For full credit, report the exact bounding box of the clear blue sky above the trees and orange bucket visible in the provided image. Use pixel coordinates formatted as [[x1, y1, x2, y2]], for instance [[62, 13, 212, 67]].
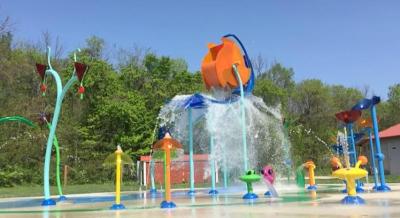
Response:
[[0, 0, 400, 98]]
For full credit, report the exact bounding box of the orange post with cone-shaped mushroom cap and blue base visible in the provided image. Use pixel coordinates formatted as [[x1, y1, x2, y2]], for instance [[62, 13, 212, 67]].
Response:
[[153, 133, 182, 208]]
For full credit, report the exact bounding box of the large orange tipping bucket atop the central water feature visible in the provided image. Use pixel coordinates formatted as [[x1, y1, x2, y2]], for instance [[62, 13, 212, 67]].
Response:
[[201, 37, 251, 89]]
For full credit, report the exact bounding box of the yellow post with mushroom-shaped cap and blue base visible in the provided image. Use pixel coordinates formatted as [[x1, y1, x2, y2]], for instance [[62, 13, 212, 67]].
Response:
[[104, 145, 133, 210]]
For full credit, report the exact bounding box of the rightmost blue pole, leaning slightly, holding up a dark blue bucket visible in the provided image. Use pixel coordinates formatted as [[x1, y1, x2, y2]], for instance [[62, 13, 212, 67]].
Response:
[[371, 104, 391, 192]]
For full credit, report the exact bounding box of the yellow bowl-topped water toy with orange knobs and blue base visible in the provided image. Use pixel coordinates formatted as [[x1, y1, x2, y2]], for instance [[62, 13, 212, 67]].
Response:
[[331, 156, 368, 204]]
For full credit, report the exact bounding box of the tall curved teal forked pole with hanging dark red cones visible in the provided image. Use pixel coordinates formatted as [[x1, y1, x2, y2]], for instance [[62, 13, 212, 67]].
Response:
[[36, 47, 89, 206]]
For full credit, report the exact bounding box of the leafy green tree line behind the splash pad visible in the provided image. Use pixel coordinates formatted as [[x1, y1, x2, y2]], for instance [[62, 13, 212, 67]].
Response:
[[0, 22, 400, 186]]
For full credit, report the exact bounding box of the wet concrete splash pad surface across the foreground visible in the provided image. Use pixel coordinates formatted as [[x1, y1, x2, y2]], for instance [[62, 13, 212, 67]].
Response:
[[0, 184, 400, 218]]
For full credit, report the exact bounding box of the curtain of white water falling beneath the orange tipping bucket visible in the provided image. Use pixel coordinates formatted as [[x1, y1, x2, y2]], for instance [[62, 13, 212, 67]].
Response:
[[159, 92, 290, 183]]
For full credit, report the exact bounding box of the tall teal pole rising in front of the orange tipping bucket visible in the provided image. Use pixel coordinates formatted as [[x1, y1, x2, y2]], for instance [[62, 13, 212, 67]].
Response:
[[232, 64, 248, 172]]
